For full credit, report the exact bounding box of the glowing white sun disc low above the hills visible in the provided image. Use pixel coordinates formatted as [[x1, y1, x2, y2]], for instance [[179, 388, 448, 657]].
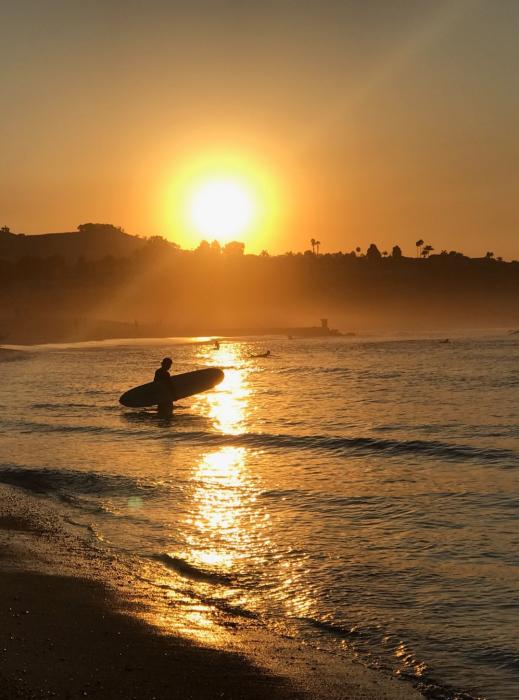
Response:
[[187, 177, 257, 242]]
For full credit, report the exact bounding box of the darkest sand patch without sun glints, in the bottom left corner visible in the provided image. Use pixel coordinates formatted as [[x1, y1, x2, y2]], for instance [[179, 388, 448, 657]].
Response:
[[0, 572, 304, 700]]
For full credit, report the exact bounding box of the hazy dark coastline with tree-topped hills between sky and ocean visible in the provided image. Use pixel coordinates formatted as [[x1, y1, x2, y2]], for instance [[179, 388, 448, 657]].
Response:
[[0, 224, 519, 343]]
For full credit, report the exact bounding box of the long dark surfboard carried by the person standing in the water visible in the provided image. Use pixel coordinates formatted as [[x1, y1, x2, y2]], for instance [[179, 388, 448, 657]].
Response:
[[119, 367, 224, 408]]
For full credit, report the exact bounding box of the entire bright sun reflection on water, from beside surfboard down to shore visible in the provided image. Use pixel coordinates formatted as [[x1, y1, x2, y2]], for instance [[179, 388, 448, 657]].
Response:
[[146, 343, 315, 644]]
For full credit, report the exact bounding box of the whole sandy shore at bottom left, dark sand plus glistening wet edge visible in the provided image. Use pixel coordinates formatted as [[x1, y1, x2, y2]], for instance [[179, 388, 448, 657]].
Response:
[[0, 484, 423, 700]]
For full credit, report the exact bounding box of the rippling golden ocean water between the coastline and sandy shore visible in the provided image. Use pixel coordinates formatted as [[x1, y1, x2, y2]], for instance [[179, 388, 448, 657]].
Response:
[[0, 332, 519, 700]]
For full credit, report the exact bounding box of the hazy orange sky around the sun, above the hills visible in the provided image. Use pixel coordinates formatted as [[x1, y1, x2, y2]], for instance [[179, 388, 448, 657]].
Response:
[[0, 0, 519, 259]]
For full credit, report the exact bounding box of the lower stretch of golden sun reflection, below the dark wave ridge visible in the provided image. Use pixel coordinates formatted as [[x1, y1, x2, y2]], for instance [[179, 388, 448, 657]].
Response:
[[152, 447, 256, 645]]
